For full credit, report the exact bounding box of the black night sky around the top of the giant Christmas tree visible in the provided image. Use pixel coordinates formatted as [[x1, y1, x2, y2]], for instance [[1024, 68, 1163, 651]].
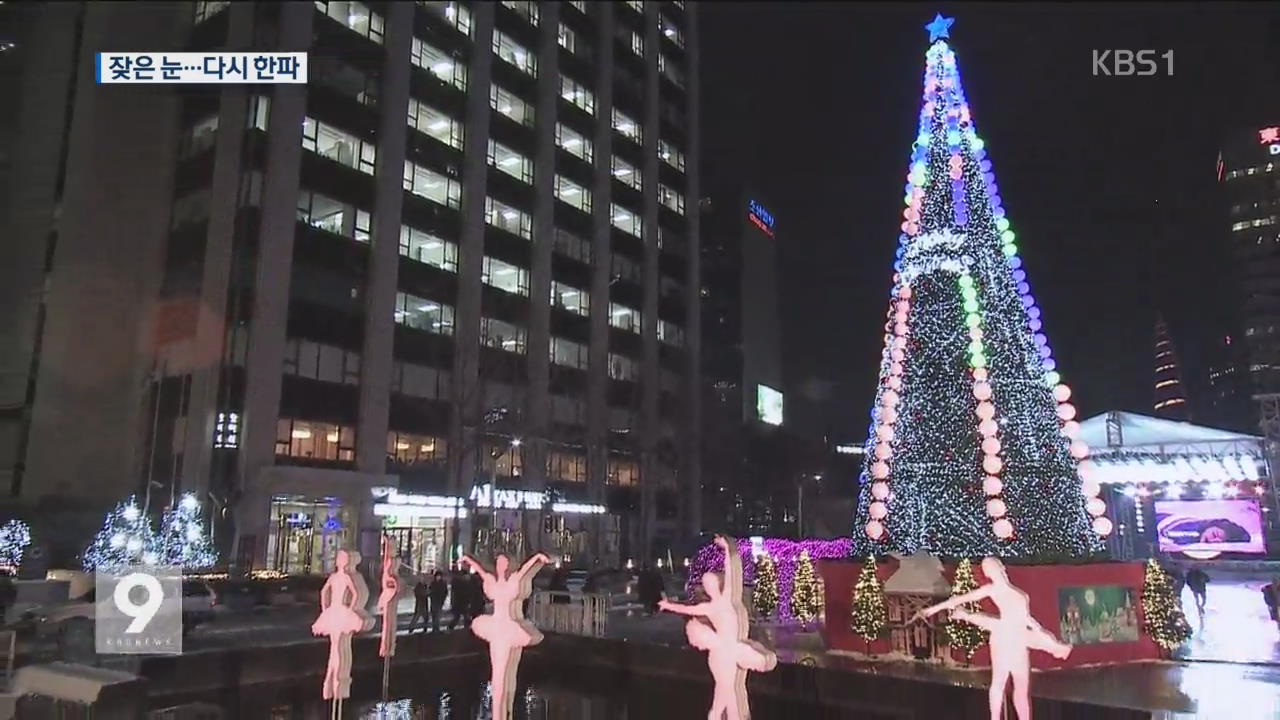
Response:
[[700, 3, 1280, 439]]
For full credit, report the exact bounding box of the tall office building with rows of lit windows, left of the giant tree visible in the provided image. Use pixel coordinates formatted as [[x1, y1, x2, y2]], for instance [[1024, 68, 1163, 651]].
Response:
[[2, 1, 700, 573]]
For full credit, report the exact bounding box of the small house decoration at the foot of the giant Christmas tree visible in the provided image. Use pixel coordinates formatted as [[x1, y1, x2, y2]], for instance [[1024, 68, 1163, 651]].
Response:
[[884, 552, 951, 662]]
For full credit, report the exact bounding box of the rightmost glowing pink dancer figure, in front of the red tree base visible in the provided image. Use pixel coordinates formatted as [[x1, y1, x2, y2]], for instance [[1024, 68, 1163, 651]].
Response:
[[913, 557, 1071, 720]]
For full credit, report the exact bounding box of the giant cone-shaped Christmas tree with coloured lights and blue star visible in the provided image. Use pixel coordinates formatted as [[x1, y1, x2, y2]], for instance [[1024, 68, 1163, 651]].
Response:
[[854, 17, 1111, 559]]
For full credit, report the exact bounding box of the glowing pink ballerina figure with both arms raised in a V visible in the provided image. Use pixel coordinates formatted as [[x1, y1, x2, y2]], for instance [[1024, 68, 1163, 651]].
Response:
[[461, 552, 552, 720]]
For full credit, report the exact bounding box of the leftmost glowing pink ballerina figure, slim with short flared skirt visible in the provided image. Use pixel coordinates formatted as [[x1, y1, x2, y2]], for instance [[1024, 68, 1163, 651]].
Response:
[[311, 550, 374, 717]]
